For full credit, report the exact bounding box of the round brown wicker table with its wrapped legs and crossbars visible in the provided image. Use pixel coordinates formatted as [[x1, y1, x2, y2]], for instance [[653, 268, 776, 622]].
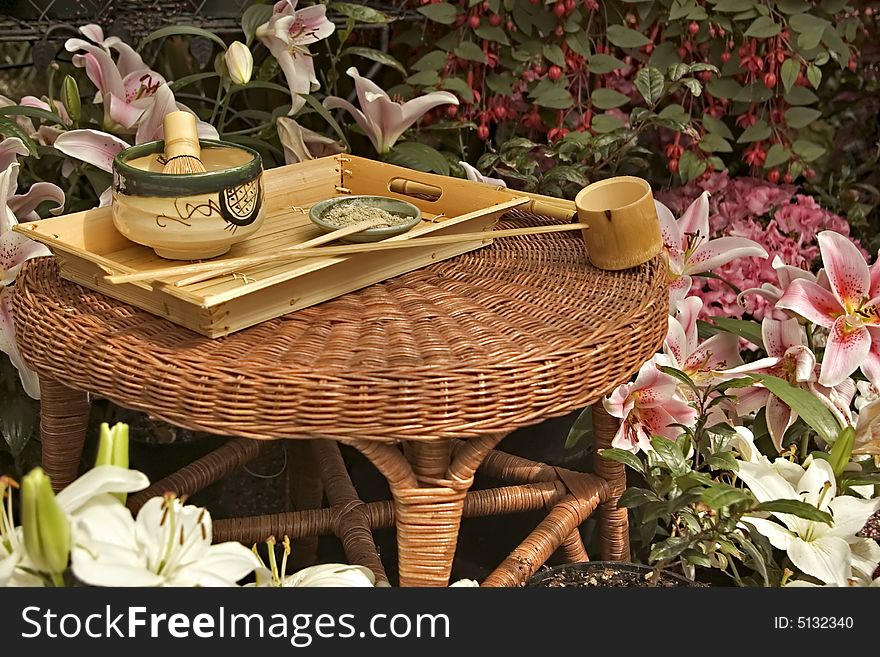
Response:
[[12, 216, 667, 586]]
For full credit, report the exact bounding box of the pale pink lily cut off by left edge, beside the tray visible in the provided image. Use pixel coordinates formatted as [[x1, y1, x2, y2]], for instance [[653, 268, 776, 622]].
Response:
[[0, 162, 51, 399]]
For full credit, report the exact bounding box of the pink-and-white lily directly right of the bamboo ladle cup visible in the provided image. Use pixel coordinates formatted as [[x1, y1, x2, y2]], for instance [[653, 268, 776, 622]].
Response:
[[655, 192, 767, 303]]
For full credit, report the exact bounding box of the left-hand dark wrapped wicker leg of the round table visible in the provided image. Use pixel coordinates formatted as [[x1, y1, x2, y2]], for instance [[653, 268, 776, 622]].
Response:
[[40, 374, 90, 492]]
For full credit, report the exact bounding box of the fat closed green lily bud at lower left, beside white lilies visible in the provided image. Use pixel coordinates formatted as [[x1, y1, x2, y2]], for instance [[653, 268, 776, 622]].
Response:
[[21, 468, 70, 584]]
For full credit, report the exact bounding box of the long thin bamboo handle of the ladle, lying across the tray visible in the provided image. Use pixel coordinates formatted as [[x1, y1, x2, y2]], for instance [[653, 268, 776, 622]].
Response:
[[104, 223, 589, 284]]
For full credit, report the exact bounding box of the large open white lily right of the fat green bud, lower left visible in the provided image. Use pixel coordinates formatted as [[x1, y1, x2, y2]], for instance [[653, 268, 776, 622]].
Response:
[[72, 492, 261, 586]]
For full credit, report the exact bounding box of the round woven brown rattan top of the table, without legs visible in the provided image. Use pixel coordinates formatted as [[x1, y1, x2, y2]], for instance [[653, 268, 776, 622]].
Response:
[[12, 217, 667, 440]]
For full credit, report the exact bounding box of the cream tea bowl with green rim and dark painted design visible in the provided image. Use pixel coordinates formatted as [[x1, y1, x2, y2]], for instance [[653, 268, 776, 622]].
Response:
[[112, 140, 264, 260]]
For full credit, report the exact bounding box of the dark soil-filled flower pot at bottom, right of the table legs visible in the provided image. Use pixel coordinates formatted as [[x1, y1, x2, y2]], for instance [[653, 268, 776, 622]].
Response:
[[526, 561, 700, 588]]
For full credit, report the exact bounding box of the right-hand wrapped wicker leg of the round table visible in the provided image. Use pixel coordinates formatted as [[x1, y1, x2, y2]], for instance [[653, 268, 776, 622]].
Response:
[[593, 402, 630, 561]]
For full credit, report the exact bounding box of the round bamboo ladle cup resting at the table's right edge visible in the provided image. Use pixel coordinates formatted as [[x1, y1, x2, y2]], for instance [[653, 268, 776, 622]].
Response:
[[574, 176, 663, 270]]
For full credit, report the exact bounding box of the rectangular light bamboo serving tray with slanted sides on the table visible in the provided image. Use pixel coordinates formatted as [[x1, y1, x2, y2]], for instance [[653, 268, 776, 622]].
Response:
[[15, 155, 540, 338]]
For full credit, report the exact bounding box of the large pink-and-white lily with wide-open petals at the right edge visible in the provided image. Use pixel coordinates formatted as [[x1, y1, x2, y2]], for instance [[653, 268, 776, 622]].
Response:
[[776, 230, 880, 386]]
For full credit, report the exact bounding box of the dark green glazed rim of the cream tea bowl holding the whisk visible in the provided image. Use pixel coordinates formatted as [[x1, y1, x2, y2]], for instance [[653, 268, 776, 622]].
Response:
[[113, 139, 263, 197]]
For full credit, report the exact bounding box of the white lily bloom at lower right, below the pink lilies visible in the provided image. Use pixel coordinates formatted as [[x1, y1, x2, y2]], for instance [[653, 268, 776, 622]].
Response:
[[738, 459, 880, 586]]
